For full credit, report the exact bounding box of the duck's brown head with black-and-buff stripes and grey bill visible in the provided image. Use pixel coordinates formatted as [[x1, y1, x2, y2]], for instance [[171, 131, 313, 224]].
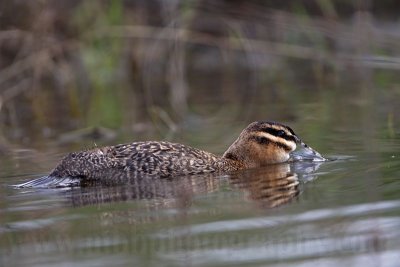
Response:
[[223, 121, 324, 168]]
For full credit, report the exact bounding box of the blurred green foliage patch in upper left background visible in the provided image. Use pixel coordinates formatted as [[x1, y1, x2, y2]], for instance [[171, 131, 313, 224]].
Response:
[[75, 0, 123, 128]]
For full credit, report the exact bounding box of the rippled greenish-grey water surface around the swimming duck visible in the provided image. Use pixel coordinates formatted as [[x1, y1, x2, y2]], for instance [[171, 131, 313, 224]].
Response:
[[0, 116, 400, 266]]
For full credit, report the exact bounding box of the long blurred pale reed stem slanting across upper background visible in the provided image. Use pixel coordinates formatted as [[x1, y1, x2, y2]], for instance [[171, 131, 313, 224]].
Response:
[[97, 26, 400, 69]]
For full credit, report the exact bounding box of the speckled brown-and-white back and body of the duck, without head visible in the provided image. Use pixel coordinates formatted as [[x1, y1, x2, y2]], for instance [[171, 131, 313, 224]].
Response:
[[50, 141, 220, 180]]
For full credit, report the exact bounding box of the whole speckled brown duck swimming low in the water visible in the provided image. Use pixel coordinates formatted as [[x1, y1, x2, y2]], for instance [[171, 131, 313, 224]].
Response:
[[21, 122, 324, 186]]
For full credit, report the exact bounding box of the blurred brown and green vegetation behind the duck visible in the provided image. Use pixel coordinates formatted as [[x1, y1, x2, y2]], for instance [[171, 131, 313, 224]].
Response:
[[0, 0, 400, 154]]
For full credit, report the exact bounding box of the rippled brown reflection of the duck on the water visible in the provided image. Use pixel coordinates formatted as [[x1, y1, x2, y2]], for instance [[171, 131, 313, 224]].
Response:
[[70, 163, 310, 209]]
